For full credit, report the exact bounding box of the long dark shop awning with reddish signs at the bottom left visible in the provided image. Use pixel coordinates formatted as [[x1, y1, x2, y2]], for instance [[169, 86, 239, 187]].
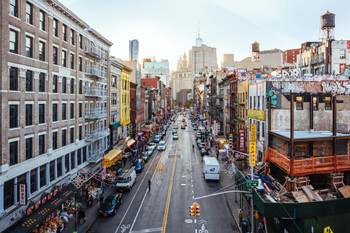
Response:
[[5, 184, 76, 233]]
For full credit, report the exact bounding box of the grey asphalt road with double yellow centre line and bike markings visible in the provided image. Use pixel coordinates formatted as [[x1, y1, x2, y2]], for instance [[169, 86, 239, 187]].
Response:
[[92, 116, 238, 233]]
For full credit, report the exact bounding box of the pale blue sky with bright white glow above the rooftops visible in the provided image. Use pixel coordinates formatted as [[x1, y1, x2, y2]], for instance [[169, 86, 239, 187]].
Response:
[[60, 0, 350, 70]]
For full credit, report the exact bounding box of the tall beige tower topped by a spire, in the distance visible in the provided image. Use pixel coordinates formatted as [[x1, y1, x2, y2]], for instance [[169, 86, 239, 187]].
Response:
[[190, 36, 218, 75]]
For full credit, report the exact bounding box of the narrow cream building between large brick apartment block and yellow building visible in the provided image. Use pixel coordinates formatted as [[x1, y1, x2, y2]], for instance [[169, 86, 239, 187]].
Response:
[[108, 57, 124, 148]]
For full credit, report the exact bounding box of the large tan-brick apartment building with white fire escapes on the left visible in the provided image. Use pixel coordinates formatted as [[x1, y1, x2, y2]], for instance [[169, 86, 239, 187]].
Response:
[[0, 0, 112, 231]]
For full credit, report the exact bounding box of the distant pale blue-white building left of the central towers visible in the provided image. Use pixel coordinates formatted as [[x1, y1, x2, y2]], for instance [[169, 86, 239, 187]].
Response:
[[142, 59, 170, 87]]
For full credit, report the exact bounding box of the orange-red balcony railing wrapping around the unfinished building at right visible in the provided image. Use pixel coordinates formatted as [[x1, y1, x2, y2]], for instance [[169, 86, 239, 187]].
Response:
[[267, 148, 350, 176]]
